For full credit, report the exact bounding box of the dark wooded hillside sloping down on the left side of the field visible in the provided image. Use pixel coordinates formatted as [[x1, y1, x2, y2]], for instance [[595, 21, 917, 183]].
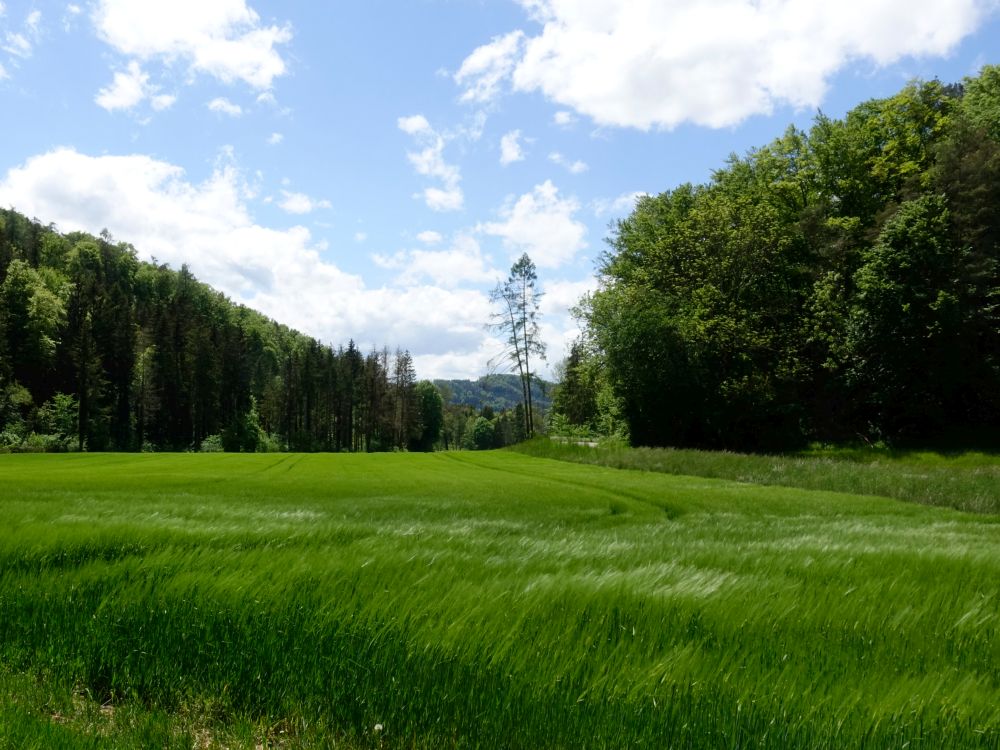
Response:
[[0, 210, 443, 451]]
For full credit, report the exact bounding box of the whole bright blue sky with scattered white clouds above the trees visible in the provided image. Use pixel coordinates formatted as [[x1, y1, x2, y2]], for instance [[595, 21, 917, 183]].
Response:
[[0, 0, 1000, 377]]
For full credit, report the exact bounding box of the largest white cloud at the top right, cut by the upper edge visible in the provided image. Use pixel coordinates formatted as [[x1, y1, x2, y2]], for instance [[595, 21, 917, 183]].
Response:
[[454, 0, 996, 129]]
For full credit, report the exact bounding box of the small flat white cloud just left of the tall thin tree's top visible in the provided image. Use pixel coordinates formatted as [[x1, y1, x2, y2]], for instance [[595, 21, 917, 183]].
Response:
[[372, 234, 500, 290]]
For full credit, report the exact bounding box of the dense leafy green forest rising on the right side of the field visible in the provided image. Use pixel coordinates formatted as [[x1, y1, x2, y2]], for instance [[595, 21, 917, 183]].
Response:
[[554, 66, 1000, 450]]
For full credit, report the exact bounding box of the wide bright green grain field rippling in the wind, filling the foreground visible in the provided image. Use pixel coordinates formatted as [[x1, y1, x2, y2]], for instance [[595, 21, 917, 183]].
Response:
[[0, 452, 1000, 748]]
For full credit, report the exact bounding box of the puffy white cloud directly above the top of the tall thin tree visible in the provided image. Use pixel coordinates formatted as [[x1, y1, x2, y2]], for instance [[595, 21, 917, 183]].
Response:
[[477, 180, 587, 268]]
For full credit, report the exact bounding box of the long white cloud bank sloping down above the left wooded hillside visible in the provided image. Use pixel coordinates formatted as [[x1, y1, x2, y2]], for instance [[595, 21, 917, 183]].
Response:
[[0, 148, 500, 378]]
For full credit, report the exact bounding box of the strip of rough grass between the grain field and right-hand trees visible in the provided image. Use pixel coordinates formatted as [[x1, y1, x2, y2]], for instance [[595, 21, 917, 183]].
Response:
[[513, 438, 1000, 514]]
